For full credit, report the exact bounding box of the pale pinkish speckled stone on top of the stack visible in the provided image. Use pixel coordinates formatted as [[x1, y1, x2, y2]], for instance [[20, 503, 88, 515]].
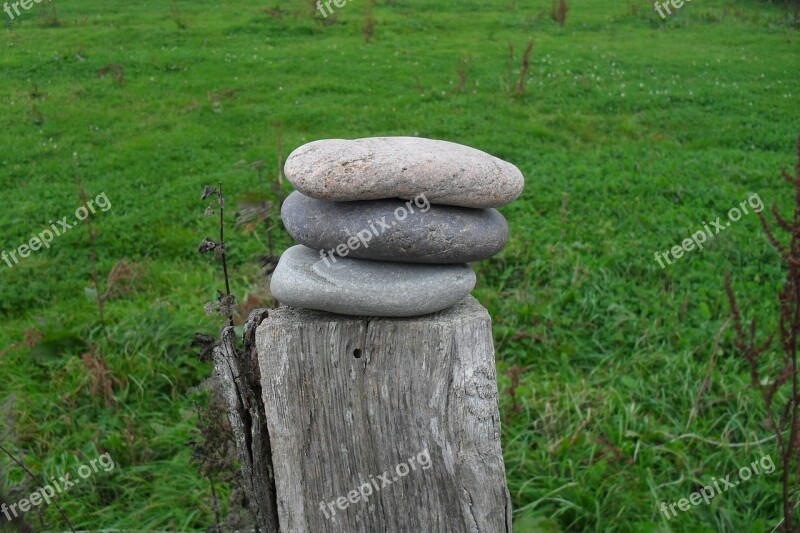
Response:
[[284, 137, 525, 207]]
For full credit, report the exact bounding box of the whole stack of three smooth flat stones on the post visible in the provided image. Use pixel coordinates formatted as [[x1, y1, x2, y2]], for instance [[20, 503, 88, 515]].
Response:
[[271, 137, 524, 317]]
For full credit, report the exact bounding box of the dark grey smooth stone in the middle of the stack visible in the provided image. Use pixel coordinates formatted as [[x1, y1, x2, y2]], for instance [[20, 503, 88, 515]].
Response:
[[281, 191, 508, 263]]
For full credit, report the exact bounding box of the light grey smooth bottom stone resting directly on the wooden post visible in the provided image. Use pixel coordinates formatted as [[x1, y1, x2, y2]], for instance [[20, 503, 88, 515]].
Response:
[[270, 245, 475, 317]]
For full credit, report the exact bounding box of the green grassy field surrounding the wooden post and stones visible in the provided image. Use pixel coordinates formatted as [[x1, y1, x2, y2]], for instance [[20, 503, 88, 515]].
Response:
[[0, 0, 800, 532]]
